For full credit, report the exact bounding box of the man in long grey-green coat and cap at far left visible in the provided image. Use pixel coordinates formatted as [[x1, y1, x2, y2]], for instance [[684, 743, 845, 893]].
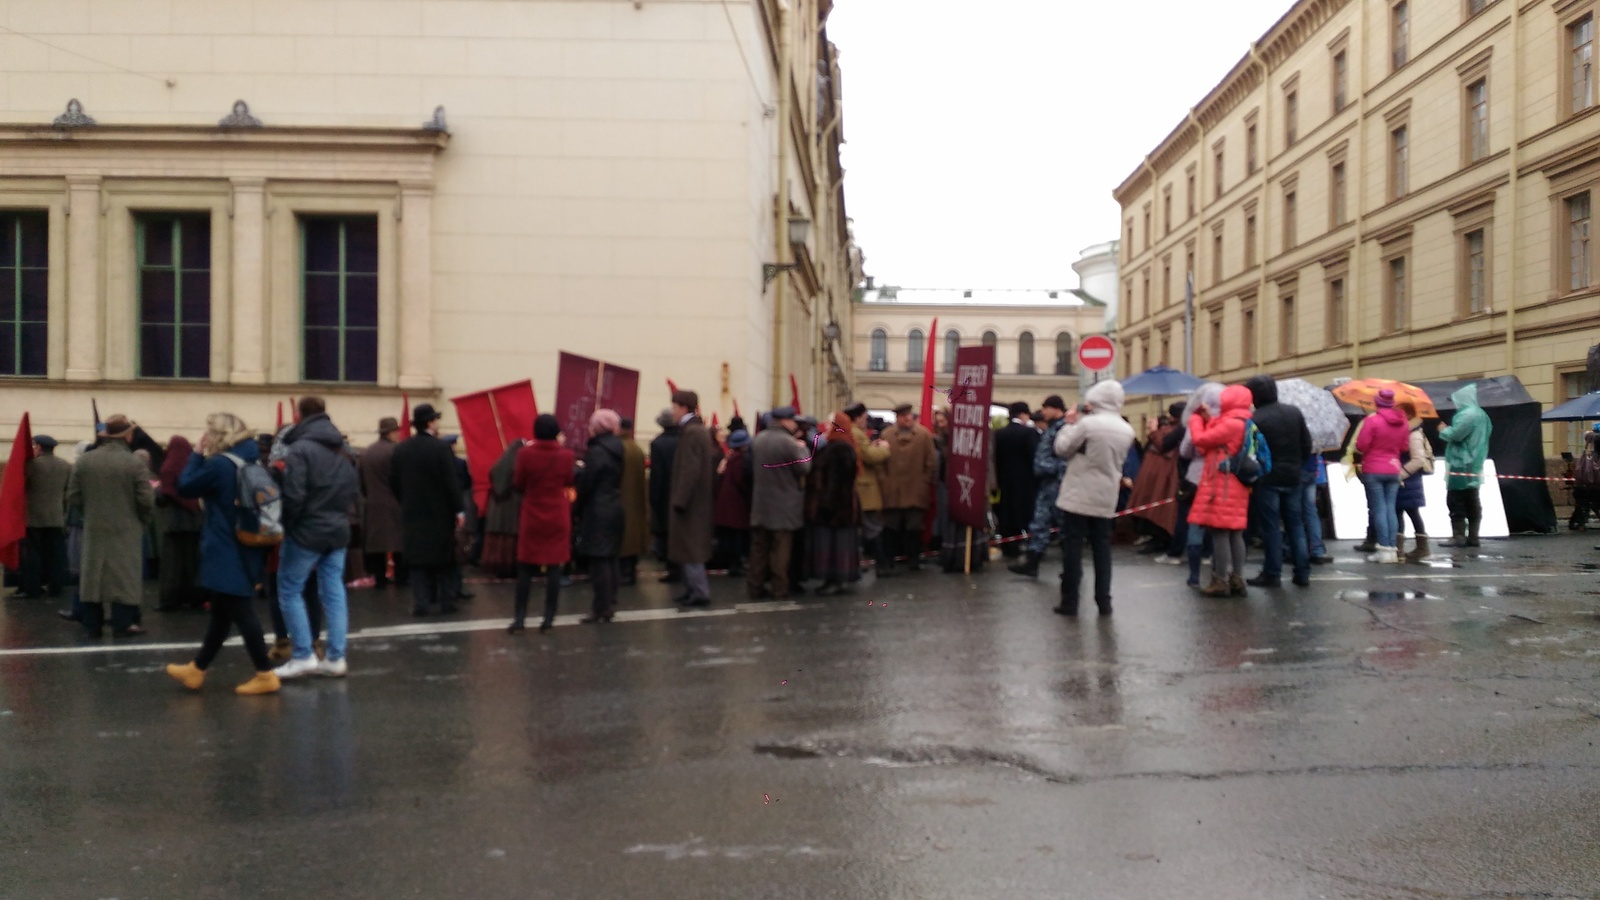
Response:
[[67, 415, 155, 639]]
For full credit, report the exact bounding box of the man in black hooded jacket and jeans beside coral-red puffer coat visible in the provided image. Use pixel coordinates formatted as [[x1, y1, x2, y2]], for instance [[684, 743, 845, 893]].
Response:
[[1245, 375, 1312, 588]]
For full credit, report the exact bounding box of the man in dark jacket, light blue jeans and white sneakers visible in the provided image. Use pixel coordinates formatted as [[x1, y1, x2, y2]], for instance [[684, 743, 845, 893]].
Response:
[[277, 397, 360, 679]]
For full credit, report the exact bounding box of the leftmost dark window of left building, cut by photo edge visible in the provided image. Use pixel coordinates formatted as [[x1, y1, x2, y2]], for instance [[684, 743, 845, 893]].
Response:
[[0, 213, 50, 376]]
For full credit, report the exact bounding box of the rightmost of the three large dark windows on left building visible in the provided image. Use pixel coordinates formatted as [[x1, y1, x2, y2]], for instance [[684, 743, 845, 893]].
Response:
[[301, 216, 378, 384]]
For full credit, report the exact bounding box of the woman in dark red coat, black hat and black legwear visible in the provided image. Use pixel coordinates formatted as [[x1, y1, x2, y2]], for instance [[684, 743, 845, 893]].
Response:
[[507, 413, 576, 634]]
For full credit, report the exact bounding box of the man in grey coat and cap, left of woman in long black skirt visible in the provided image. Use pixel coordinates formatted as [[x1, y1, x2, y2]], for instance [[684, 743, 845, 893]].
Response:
[[746, 407, 811, 601]]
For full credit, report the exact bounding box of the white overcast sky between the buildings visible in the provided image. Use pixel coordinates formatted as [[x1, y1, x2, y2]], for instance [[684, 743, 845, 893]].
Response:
[[829, 0, 1293, 287]]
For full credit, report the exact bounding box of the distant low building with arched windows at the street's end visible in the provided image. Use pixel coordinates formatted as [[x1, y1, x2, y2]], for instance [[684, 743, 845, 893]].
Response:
[[854, 283, 1115, 408]]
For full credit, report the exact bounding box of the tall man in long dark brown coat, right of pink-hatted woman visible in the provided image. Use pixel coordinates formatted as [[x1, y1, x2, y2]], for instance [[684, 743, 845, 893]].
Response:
[[667, 391, 717, 607]]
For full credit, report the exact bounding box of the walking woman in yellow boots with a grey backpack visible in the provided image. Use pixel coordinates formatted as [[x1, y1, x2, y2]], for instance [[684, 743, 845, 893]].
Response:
[[166, 413, 278, 695]]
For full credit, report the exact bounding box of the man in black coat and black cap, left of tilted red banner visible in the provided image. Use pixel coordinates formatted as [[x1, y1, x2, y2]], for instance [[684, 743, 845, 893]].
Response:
[[389, 404, 464, 617]]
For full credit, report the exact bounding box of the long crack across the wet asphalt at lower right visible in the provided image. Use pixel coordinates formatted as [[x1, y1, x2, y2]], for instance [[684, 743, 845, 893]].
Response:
[[754, 740, 1600, 785]]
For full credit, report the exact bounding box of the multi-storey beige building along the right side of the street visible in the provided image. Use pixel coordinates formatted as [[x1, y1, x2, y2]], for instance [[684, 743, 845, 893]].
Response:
[[1115, 0, 1600, 452]]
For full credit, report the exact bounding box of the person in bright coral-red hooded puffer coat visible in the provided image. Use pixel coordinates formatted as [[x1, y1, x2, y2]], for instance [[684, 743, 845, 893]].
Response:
[[1189, 384, 1254, 597]]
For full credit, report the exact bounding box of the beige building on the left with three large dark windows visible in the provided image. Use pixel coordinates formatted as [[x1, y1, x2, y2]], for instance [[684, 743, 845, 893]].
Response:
[[0, 0, 861, 440]]
